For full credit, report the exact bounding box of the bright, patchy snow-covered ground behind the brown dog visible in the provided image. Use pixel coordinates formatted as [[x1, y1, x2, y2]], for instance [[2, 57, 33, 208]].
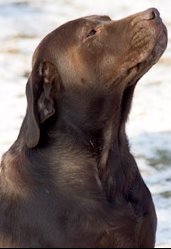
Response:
[[0, 0, 171, 248]]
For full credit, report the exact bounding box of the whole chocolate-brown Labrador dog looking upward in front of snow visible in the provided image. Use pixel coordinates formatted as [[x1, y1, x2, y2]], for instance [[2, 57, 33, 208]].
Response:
[[0, 9, 167, 248]]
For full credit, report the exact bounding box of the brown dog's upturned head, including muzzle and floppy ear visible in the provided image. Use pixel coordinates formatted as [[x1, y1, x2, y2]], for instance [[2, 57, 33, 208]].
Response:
[[26, 9, 167, 148]]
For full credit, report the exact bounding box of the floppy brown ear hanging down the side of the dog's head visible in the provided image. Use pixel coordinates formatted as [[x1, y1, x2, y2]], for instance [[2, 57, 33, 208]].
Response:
[[25, 62, 59, 148]]
